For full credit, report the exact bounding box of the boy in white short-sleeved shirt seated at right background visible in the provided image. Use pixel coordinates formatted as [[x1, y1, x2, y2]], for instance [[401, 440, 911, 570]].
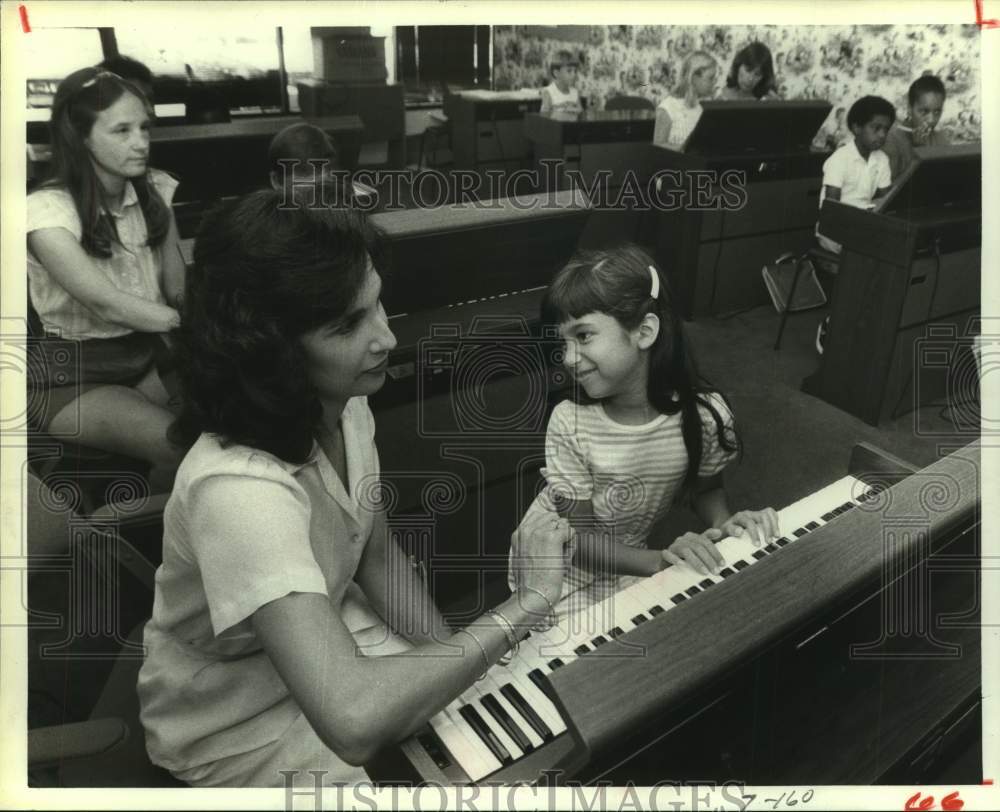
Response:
[[816, 96, 896, 254]]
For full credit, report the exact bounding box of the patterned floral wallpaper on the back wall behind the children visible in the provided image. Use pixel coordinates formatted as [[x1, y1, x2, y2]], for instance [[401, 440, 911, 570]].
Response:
[[493, 25, 982, 147]]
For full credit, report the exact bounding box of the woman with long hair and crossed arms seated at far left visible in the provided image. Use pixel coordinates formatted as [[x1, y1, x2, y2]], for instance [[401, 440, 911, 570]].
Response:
[[27, 68, 185, 488]]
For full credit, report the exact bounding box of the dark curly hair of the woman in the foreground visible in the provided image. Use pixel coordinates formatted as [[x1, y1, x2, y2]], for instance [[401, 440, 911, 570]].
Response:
[[171, 190, 382, 463]]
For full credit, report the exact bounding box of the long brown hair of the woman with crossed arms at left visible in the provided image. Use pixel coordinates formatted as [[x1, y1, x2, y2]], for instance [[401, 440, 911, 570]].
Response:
[[43, 68, 170, 257]]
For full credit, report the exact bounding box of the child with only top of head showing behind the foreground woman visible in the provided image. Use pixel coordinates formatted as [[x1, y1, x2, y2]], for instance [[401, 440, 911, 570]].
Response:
[[267, 121, 378, 211]]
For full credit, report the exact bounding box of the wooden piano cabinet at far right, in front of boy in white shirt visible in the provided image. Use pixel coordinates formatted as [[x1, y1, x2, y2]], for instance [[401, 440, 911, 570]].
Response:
[[802, 201, 982, 425]]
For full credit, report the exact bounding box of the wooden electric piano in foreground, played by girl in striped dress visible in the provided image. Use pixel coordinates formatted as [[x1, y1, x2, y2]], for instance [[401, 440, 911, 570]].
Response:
[[369, 442, 982, 786]]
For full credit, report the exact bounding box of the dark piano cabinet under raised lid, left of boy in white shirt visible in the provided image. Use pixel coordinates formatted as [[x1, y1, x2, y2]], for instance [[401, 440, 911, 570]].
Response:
[[647, 145, 829, 318]]
